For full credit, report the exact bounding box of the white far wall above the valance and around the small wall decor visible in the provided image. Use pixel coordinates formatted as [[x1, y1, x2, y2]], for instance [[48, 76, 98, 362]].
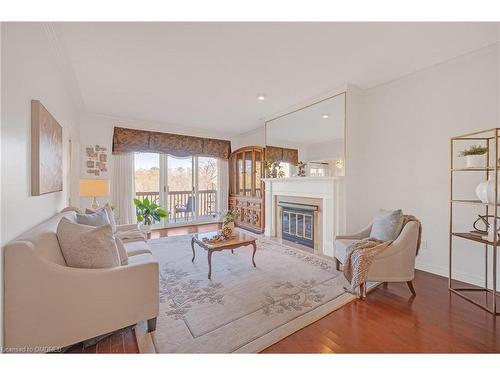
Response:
[[80, 114, 230, 208]]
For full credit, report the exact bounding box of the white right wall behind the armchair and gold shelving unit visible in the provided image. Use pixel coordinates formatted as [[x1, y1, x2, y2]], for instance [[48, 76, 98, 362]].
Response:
[[347, 44, 500, 285]]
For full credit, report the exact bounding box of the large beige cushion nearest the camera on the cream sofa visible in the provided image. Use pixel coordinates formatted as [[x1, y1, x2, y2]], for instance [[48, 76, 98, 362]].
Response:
[[57, 217, 120, 268]]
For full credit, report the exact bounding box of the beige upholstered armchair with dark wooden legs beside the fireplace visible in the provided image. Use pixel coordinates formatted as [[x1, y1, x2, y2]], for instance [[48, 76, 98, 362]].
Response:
[[334, 221, 419, 296]]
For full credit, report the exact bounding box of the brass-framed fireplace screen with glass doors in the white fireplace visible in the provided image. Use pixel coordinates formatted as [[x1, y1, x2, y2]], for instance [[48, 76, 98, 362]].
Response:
[[280, 203, 317, 249]]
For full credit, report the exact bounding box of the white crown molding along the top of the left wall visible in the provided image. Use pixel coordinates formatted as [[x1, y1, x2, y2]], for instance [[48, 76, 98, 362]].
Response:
[[41, 22, 86, 113]]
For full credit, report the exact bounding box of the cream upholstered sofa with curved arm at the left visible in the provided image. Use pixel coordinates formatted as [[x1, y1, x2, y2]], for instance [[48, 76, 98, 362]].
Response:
[[3, 211, 159, 352]]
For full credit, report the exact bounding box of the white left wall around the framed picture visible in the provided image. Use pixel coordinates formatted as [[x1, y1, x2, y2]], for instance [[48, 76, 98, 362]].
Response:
[[1, 23, 79, 245]]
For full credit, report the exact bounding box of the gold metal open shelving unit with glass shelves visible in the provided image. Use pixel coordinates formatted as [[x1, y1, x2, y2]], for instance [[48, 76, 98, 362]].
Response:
[[448, 128, 500, 315]]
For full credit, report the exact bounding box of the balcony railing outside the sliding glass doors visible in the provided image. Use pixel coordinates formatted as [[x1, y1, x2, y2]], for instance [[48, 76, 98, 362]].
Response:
[[135, 190, 217, 222]]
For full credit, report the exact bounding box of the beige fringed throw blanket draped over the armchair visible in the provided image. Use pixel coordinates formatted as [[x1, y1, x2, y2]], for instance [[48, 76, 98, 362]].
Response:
[[344, 215, 422, 293]]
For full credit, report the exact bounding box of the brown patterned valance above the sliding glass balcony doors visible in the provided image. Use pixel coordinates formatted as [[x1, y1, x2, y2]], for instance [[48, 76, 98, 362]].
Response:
[[113, 126, 231, 159]]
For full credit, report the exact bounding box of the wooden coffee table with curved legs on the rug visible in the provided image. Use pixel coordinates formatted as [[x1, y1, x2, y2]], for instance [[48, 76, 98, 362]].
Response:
[[191, 232, 257, 279]]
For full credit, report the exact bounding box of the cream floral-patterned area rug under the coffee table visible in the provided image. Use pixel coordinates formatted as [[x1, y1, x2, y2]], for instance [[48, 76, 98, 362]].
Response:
[[146, 236, 355, 353]]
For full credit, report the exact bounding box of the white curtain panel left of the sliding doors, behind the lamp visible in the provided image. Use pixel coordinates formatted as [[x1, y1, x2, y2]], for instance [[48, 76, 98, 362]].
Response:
[[111, 153, 137, 224]]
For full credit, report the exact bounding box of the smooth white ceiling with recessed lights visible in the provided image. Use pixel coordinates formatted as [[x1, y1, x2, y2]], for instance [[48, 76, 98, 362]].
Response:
[[55, 23, 498, 134]]
